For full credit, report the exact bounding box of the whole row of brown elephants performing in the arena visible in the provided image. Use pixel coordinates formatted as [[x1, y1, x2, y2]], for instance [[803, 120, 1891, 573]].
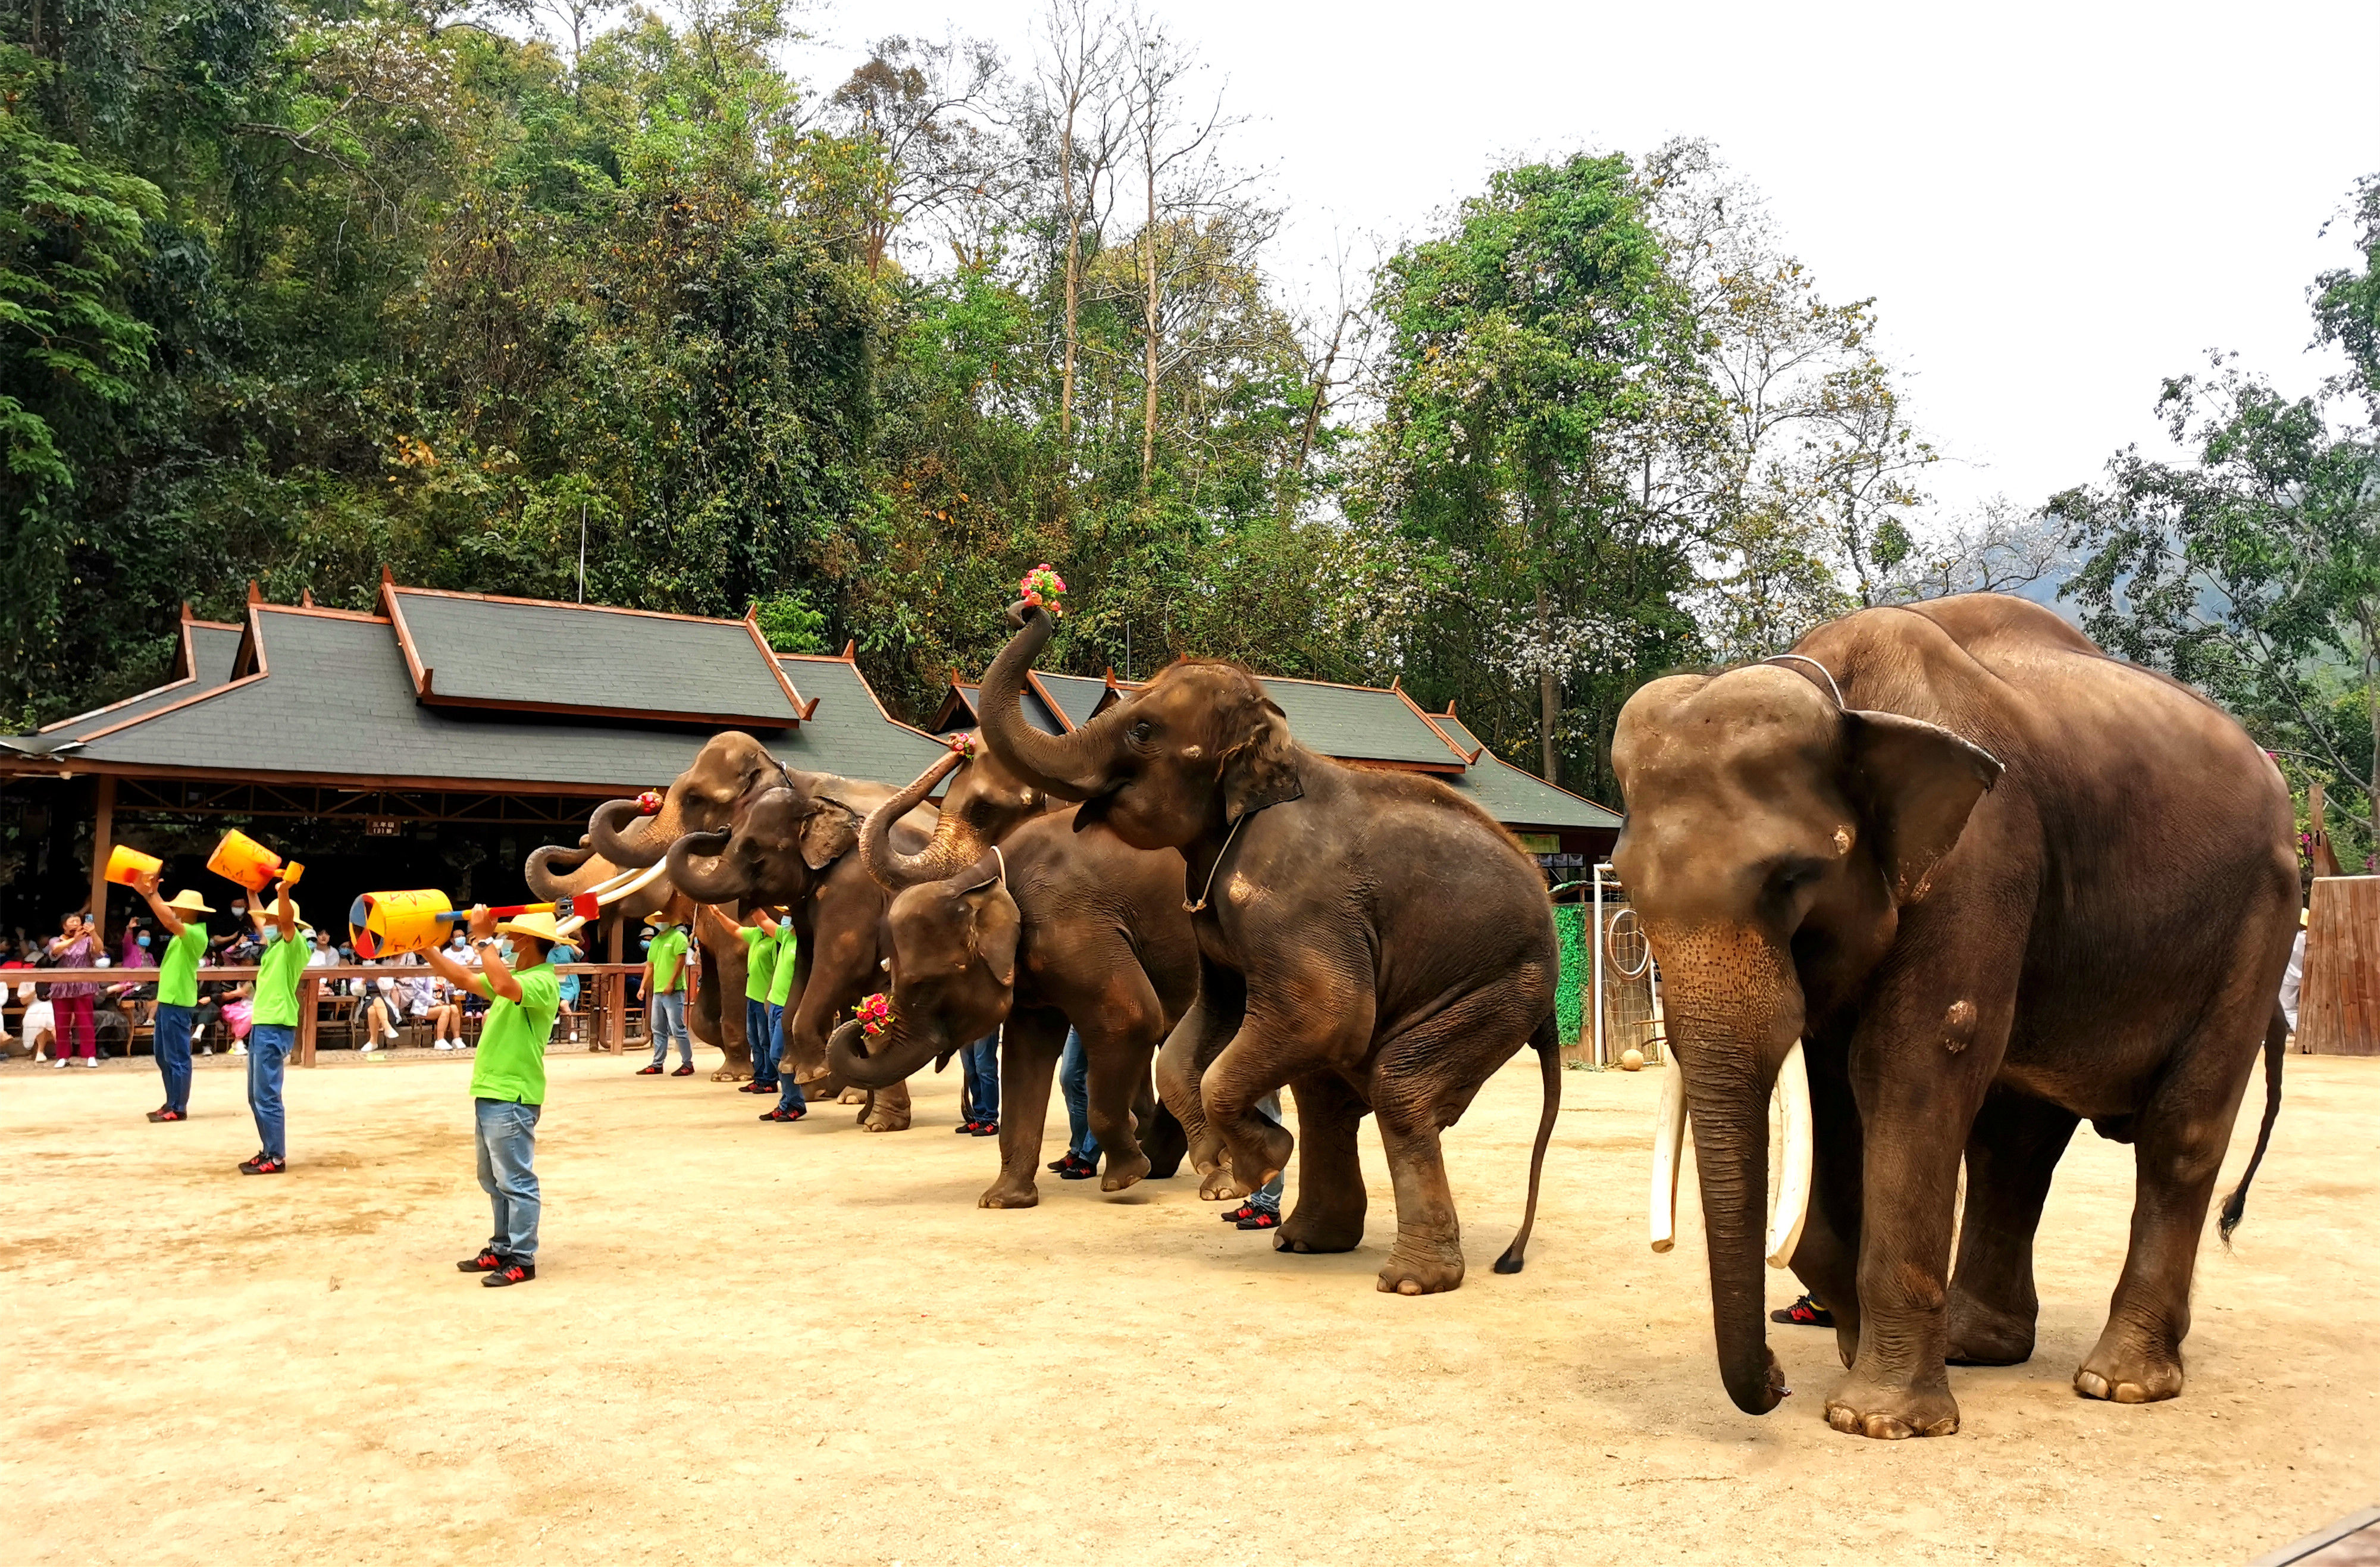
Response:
[[531, 595, 2299, 1436]]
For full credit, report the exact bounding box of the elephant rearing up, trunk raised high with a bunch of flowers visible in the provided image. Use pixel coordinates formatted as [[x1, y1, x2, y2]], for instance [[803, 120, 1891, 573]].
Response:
[[981, 605, 1561, 1296]]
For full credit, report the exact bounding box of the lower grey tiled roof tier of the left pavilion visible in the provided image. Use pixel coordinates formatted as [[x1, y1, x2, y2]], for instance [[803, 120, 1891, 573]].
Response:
[[26, 605, 940, 793]]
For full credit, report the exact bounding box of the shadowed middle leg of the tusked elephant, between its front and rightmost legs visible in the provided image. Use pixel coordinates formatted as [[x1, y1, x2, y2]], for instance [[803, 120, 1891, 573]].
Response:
[[1944, 1091, 2078, 1365]]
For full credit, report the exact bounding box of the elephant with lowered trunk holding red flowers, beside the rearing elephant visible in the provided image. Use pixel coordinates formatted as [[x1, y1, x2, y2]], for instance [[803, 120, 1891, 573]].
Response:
[[826, 755, 1197, 1208]]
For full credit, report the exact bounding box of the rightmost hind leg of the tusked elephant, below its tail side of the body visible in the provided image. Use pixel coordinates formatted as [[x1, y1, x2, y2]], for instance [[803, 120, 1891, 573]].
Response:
[[2075, 984, 2273, 1403]]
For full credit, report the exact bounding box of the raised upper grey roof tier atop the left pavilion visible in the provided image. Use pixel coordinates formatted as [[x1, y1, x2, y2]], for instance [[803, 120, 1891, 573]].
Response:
[[386, 588, 814, 740]]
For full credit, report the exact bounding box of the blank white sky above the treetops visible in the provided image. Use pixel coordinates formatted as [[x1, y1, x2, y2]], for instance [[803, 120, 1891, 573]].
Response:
[[793, 0, 2380, 524]]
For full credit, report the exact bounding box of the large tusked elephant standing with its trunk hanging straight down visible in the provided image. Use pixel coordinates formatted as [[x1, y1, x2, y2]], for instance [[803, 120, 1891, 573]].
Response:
[[1611, 593, 2297, 1438]]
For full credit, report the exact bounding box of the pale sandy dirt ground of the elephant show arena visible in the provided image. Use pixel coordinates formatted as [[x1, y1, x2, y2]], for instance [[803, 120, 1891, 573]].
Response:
[[0, 1033, 2380, 1567]]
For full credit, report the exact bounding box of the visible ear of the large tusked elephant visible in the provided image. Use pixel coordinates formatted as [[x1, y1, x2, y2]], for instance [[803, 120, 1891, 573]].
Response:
[[1842, 709, 2002, 903]]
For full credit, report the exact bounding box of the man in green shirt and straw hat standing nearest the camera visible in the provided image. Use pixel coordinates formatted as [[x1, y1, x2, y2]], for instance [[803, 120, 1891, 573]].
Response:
[[426, 905, 562, 1288]]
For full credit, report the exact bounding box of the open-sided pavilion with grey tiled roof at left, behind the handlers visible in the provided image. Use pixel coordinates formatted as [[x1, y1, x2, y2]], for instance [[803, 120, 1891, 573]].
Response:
[[0, 581, 940, 927]]
